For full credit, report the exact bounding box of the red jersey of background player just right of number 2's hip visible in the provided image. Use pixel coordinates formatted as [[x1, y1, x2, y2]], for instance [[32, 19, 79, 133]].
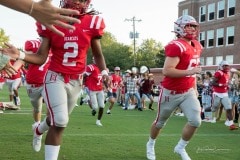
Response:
[[85, 64, 103, 91]]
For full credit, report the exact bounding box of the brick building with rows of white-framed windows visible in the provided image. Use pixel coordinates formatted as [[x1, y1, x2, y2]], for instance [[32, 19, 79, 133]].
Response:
[[178, 0, 240, 69]]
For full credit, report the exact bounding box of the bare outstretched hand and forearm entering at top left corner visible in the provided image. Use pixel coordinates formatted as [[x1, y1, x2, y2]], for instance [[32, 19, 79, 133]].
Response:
[[0, 0, 80, 36]]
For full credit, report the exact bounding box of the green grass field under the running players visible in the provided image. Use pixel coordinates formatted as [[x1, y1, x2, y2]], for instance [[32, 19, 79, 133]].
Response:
[[0, 86, 240, 160]]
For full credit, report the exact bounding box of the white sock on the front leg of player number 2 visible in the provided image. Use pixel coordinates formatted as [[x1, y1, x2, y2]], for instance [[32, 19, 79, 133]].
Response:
[[45, 145, 60, 160]]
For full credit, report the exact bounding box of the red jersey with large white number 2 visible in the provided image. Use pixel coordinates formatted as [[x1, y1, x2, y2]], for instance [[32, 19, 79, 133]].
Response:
[[37, 14, 105, 74]]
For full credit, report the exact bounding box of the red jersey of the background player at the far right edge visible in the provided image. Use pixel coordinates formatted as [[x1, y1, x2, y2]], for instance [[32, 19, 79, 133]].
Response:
[[213, 70, 230, 93]]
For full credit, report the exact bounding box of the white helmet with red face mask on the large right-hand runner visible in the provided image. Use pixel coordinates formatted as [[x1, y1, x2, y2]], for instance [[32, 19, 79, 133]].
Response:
[[174, 15, 199, 40]]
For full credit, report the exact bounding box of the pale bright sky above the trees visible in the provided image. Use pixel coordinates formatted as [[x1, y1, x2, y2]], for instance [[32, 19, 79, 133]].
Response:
[[0, 0, 182, 47]]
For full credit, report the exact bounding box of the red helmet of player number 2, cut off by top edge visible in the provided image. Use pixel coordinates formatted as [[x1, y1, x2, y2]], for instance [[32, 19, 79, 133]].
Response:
[[60, 0, 91, 14]]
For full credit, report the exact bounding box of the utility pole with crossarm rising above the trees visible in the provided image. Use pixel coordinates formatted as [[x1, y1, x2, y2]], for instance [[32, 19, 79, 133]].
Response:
[[125, 16, 142, 66]]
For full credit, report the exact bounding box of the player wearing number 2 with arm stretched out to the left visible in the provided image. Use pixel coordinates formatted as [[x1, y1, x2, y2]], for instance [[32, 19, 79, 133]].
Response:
[[0, 0, 107, 160]]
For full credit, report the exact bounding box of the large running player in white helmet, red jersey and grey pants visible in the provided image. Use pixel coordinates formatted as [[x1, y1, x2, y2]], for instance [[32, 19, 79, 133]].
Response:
[[146, 15, 202, 160]]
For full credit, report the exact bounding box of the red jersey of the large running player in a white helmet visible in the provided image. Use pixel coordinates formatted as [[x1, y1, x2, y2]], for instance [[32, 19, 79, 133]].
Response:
[[161, 39, 202, 91]]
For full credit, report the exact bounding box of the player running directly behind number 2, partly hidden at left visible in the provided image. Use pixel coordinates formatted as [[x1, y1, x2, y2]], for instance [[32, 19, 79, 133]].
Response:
[[24, 39, 51, 152]]
